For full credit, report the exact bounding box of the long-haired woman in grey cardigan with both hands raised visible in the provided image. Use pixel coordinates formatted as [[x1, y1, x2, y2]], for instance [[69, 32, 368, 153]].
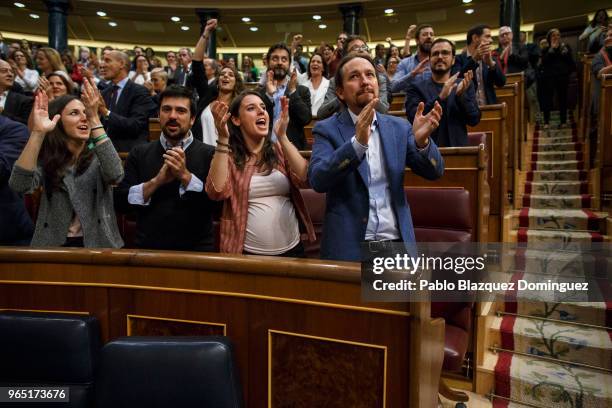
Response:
[[9, 81, 123, 248]]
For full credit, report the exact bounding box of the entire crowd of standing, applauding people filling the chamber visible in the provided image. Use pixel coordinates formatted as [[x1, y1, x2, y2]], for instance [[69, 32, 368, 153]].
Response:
[[0, 12, 612, 260]]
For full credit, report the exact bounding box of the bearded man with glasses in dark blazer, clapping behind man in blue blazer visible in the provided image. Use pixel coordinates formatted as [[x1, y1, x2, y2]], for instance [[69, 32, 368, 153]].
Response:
[[406, 38, 480, 147]]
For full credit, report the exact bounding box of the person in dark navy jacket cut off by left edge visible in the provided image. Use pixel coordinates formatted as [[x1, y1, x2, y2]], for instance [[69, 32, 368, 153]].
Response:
[[0, 116, 34, 245]]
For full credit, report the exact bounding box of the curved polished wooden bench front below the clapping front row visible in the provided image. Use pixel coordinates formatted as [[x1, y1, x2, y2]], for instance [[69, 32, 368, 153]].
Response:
[[0, 248, 444, 407]]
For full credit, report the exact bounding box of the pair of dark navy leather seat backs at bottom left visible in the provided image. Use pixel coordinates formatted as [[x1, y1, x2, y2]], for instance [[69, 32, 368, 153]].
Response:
[[0, 311, 243, 408]]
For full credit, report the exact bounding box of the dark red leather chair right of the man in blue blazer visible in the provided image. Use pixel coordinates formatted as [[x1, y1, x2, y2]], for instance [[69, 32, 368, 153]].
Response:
[[404, 187, 475, 401]]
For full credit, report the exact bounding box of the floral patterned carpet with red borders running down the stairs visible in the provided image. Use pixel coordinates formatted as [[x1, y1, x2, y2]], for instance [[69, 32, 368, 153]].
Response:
[[489, 115, 612, 408]]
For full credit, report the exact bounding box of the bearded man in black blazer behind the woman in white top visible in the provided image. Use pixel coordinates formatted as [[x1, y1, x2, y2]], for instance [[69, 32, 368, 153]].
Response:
[[258, 43, 312, 150]]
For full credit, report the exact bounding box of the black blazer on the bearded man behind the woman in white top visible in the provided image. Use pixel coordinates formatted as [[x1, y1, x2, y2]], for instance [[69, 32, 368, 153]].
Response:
[[258, 85, 312, 150]]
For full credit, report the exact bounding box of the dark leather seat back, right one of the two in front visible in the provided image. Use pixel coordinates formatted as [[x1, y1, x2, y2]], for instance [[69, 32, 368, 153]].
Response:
[[96, 337, 243, 408]]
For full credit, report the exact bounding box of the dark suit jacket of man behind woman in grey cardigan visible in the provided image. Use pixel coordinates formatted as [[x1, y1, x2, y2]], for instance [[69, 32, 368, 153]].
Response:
[[102, 81, 155, 152]]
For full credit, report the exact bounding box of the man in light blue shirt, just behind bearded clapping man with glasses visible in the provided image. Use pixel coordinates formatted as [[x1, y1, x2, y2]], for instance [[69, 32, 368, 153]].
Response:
[[390, 24, 434, 93]]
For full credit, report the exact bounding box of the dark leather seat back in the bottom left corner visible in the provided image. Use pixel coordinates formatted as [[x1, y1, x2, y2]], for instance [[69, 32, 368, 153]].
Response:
[[0, 311, 100, 408]]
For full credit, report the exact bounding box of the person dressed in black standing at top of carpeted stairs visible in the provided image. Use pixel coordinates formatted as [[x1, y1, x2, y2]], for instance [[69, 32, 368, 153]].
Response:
[[538, 28, 576, 127]]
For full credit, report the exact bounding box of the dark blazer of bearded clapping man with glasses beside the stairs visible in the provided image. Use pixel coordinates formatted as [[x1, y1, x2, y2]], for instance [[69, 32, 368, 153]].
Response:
[[406, 78, 481, 147]]
